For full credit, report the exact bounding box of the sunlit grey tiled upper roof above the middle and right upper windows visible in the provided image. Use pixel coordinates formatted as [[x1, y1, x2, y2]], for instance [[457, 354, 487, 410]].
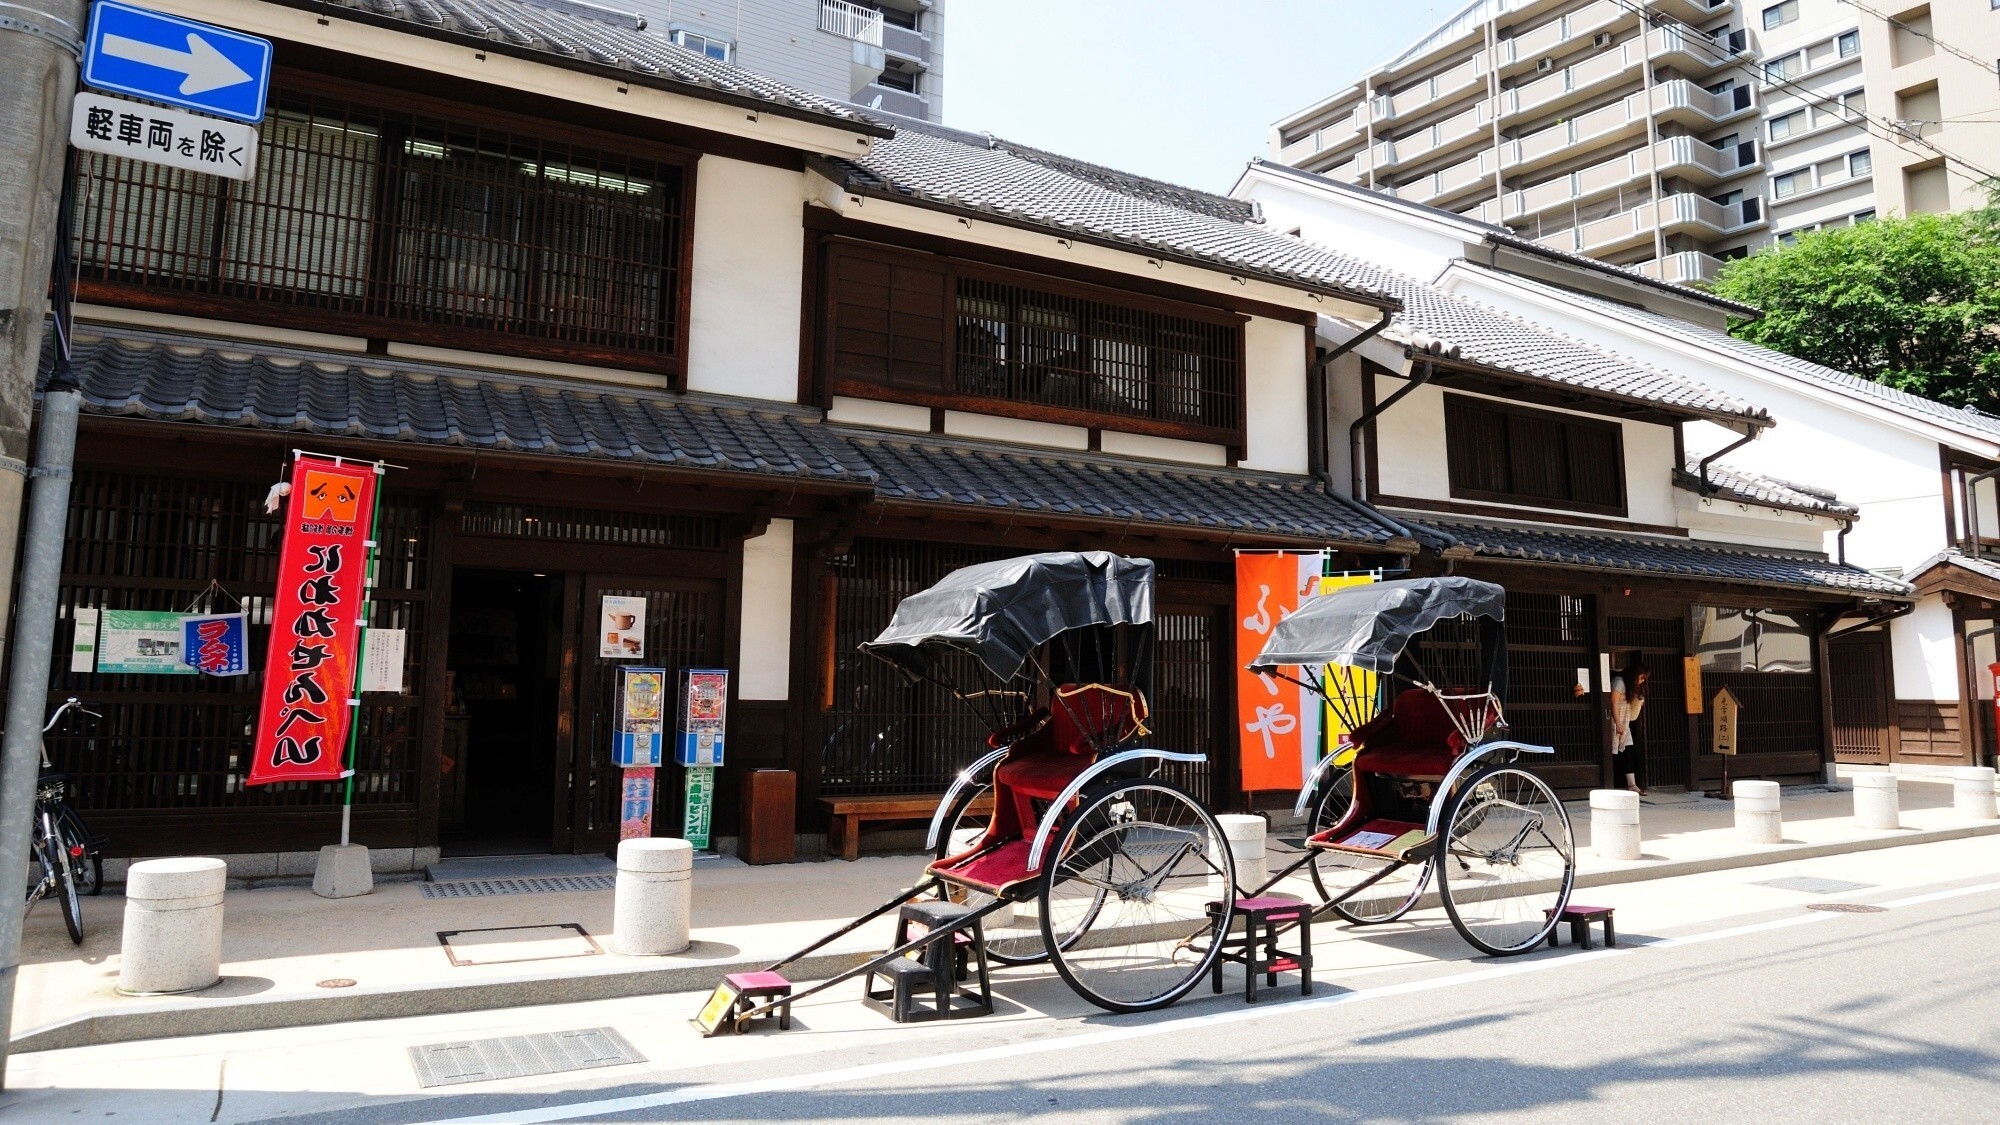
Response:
[[820, 118, 1768, 422]]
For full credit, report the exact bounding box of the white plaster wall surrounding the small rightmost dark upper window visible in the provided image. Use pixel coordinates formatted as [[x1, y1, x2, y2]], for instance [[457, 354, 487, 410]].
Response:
[[1368, 376, 1678, 526]]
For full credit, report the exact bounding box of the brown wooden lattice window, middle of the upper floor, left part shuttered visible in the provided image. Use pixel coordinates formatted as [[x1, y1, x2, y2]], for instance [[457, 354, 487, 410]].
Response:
[[826, 242, 1244, 446]]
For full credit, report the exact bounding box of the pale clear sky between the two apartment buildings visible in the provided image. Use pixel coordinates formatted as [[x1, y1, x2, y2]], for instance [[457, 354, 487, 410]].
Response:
[[944, 0, 1464, 192]]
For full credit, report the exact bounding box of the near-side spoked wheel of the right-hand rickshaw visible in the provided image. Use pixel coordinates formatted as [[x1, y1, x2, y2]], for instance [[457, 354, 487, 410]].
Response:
[[1434, 765, 1576, 957]]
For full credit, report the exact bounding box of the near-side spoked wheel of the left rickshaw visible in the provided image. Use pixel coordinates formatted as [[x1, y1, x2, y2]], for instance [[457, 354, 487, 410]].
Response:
[[1040, 781, 1236, 1013]]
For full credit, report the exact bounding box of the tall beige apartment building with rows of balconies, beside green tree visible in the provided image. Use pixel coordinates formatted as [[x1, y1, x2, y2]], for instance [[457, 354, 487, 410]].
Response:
[[1270, 0, 2000, 282]]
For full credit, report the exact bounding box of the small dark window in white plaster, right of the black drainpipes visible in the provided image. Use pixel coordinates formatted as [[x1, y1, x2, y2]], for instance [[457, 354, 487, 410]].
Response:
[[1444, 394, 1626, 516]]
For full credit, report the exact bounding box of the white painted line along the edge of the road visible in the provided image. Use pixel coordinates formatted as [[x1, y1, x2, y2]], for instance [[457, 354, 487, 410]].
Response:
[[406, 883, 2000, 1125]]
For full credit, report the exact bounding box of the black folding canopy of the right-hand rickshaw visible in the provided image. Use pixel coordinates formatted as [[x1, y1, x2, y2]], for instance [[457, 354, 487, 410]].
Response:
[[1250, 577, 1506, 679]]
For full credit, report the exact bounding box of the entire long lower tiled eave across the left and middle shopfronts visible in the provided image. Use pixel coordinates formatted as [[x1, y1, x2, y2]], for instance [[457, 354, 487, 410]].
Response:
[[42, 324, 1396, 544]]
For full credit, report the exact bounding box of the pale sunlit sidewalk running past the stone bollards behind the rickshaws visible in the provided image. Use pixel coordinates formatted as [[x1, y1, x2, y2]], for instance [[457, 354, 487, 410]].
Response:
[[14, 777, 2000, 1051]]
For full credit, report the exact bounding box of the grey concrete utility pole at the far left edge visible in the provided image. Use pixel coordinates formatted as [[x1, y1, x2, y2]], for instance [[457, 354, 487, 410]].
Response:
[[0, 0, 84, 1085]]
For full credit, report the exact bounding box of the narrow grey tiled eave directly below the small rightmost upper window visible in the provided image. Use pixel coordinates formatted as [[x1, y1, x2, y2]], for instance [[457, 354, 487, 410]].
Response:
[[1404, 516, 1910, 597]]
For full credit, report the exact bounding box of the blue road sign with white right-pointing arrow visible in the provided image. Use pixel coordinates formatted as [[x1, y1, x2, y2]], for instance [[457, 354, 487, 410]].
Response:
[[84, 0, 270, 124]]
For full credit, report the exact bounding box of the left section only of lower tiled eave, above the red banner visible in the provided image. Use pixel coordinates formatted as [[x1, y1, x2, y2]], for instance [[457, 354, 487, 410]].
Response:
[[44, 324, 874, 484]]
